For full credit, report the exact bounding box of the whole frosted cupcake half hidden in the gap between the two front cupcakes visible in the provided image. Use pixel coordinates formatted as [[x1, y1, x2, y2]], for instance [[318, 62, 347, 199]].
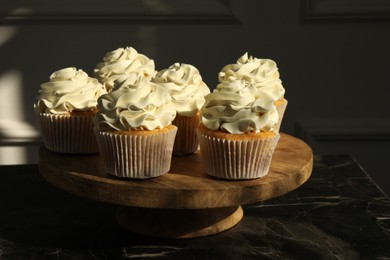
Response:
[[152, 63, 210, 155]]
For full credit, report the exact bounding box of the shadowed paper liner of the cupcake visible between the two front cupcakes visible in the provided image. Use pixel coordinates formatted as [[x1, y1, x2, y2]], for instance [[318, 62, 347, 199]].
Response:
[[172, 115, 199, 155]]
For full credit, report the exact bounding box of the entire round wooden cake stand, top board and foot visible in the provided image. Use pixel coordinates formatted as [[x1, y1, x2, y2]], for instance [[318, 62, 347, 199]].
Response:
[[39, 133, 313, 238]]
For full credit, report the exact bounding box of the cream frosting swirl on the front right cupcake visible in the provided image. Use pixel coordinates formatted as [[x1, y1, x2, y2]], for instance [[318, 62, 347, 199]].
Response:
[[201, 79, 279, 134]]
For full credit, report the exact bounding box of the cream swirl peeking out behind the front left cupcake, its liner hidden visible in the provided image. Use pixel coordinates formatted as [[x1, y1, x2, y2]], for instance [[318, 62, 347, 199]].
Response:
[[94, 47, 156, 90]]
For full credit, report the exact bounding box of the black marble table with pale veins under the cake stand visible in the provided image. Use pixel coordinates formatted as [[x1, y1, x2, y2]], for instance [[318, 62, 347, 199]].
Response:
[[0, 156, 390, 259]]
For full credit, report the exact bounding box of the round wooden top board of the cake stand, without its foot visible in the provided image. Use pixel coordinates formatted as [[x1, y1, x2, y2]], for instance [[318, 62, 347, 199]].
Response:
[[39, 133, 313, 209]]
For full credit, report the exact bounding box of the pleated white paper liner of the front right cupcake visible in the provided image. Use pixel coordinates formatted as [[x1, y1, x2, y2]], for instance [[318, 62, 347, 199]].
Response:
[[198, 130, 280, 180]]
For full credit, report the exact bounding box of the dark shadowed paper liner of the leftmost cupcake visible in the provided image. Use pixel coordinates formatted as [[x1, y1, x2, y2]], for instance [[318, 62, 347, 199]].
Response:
[[39, 113, 99, 154]]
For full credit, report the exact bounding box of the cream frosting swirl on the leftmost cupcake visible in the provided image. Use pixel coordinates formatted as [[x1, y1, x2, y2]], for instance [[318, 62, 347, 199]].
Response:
[[34, 67, 107, 114]]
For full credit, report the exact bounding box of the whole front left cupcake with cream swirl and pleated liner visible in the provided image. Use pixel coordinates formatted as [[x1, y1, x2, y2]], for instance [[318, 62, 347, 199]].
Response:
[[94, 74, 177, 179]]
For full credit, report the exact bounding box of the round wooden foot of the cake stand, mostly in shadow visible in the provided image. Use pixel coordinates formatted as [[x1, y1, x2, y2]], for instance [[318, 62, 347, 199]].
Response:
[[117, 206, 243, 238]]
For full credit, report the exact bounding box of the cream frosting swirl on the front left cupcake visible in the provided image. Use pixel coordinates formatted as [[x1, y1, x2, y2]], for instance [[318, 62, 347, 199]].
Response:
[[95, 76, 176, 131]]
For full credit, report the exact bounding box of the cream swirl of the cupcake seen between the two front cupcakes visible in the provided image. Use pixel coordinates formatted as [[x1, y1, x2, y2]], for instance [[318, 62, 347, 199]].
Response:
[[152, 63, 210, 117]]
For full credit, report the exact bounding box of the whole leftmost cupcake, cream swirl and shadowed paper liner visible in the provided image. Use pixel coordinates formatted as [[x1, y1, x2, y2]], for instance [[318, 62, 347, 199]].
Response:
[[34, 67, 106, 154]]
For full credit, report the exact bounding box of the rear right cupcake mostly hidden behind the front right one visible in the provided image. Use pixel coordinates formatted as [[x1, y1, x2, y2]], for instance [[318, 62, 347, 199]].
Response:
[[218, 53, 287, 132]]
